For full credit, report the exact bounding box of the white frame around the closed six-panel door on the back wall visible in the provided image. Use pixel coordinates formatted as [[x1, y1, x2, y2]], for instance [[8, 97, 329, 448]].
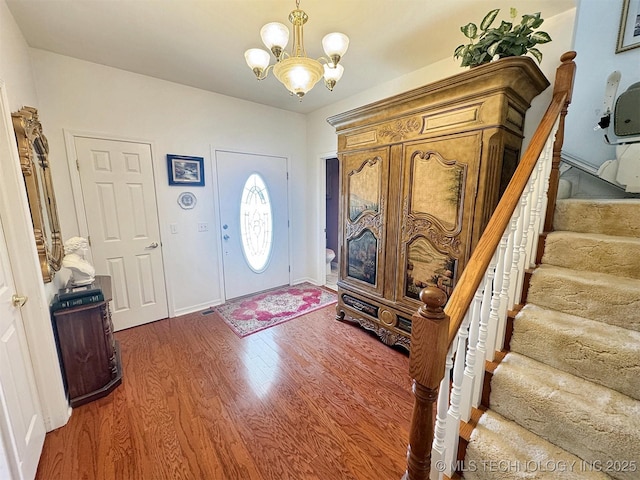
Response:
[[63, 129, 175, 317]]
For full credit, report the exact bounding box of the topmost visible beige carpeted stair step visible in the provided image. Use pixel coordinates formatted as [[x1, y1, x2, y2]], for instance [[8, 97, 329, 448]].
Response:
[[553, 198, 640, 237]]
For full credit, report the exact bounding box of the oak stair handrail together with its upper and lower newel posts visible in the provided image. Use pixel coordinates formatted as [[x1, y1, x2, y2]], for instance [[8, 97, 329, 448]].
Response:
[[403, 52, 576, 480]]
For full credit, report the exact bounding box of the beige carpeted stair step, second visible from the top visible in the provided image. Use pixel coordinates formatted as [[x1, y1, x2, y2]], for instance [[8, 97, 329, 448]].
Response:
[[542, 231, 640, 279]]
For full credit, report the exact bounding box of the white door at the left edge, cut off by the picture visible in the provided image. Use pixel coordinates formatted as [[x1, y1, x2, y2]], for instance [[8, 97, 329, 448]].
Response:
[[0, 215, 45, 480]]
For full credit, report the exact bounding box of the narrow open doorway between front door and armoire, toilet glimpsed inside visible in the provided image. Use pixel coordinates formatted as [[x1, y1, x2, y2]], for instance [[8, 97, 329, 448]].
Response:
[[325, 158, 340, 290]]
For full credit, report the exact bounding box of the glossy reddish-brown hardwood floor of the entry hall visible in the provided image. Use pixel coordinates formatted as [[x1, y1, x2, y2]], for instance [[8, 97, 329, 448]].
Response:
[[36, 305, 413, 480]]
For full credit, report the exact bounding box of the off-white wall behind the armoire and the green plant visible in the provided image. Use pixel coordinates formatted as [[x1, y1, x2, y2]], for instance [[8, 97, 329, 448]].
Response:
[[307, 9, 576, 278]]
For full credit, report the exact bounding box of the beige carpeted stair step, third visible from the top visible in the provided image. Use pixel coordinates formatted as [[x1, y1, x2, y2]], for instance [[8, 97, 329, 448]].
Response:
[[527, 265, 640, 331]]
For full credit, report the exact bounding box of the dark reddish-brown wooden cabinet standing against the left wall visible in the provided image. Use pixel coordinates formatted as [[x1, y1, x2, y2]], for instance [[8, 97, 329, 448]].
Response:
[[52, 278, 122, 407]]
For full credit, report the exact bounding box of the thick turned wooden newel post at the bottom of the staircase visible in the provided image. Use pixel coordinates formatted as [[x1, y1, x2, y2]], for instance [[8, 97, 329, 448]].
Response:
[[403, 287, 449, 480]]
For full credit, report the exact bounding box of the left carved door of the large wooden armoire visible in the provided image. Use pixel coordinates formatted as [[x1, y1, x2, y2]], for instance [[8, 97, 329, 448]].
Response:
[[341, 148, 389, 294]]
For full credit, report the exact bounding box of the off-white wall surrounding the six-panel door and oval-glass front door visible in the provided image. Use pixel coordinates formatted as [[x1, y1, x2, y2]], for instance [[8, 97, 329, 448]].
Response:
[[31, 49, 308, 316]]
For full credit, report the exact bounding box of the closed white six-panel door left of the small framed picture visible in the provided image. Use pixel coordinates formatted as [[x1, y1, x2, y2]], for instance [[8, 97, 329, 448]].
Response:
[[74, 137, 168, 330]]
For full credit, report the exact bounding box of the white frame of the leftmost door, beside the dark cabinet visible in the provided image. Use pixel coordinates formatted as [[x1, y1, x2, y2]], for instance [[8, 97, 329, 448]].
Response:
[[0, 79, 71, 431]]
